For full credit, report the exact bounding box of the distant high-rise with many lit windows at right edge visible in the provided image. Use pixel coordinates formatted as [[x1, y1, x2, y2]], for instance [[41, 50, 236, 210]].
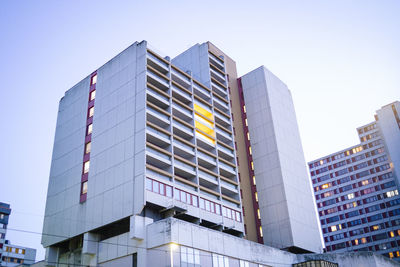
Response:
[[309, 101, 400, 260]]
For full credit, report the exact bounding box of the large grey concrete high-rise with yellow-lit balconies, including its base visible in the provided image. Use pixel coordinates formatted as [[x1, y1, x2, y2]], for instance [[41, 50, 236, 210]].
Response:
[[42, 41, 396, 267]]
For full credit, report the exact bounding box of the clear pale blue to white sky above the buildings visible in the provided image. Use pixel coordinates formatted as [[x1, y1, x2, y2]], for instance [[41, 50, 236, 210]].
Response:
[[0, 0, 400, 260]]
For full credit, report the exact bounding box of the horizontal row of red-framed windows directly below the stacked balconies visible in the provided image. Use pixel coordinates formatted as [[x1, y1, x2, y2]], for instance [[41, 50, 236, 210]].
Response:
[[146, 178, 242, 222]]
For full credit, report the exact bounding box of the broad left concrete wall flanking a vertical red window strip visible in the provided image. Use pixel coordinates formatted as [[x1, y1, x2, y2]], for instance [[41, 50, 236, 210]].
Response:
[[42, 42, 146, 247]]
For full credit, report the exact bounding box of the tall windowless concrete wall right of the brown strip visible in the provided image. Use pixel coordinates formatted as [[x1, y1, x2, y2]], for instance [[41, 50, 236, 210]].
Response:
[[242, 66, 322, 252]]
